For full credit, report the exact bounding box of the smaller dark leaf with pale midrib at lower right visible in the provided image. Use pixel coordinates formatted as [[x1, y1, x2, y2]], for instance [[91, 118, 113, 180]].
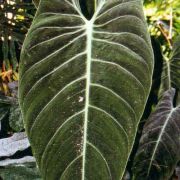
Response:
[[134, 89, 180, 180]]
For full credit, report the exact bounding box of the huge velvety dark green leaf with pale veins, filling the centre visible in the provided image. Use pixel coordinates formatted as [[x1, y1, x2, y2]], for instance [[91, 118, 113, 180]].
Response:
[[19, 0, 153, 180]]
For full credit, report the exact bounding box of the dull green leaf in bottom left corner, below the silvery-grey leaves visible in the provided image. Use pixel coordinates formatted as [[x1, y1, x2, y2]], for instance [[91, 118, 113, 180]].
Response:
[[0, 162, 42, 180]]
